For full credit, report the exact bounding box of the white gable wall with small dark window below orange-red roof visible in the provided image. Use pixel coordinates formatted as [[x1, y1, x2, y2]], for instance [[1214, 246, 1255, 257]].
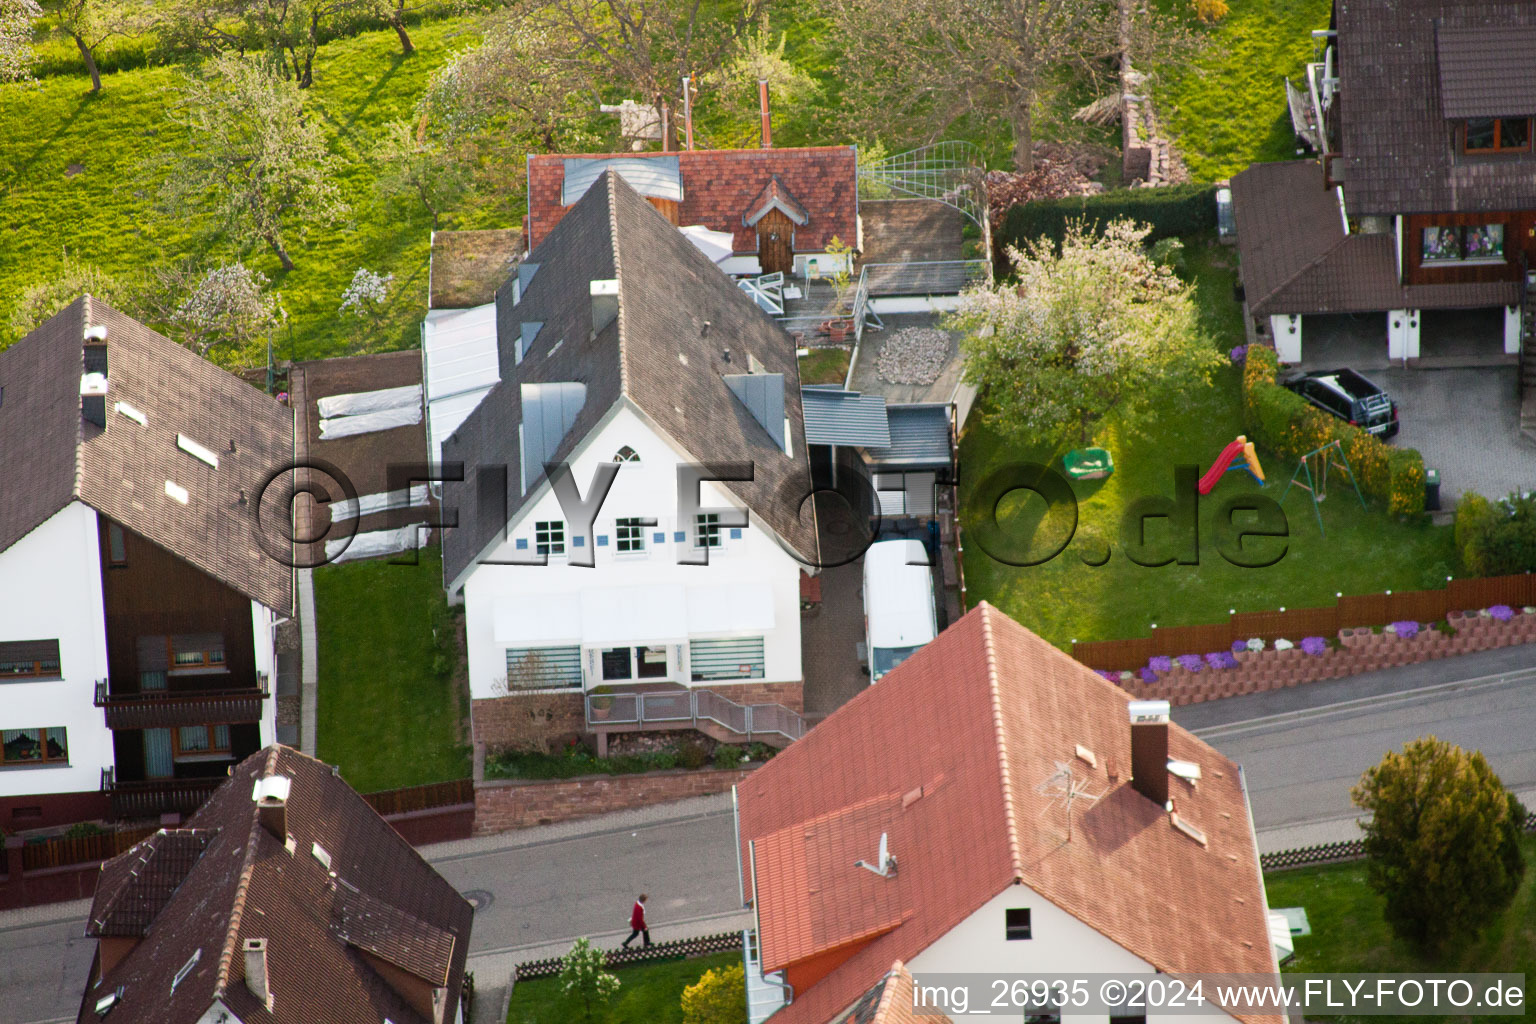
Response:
[[908, 886, 1232, 1024]]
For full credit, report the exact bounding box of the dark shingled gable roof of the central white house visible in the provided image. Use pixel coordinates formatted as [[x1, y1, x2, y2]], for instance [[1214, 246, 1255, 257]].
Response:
[[442, 170, 817, 590]]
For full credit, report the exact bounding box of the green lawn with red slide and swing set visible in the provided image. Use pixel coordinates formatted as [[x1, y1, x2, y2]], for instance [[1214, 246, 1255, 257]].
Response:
[[960, 238, 1455, 644]]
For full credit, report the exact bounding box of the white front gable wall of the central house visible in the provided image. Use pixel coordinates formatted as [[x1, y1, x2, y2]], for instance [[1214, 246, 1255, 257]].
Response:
[[464, 401, 802, 697]]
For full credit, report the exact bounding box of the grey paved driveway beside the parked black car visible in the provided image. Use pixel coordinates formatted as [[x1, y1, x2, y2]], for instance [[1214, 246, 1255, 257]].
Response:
[[1370, 367, 1536, 508]]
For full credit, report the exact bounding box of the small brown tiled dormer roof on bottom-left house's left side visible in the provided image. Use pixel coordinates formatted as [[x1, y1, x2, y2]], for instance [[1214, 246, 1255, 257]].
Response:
[[86, 829, 218, 936]]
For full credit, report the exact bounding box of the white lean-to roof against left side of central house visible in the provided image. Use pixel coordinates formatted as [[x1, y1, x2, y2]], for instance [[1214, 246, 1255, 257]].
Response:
[[421, 302, 501, 462]]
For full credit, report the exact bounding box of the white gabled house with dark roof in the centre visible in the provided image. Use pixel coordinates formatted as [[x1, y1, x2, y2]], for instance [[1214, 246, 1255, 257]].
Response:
[[425, 172, 817, 742]]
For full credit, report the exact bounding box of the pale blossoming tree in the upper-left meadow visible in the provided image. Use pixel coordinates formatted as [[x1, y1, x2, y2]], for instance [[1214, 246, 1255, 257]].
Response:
[[161, 54, 346, 270]]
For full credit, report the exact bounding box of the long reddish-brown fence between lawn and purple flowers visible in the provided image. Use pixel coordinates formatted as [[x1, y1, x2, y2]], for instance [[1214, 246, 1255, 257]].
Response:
[[1072, 573, 1536, 672]]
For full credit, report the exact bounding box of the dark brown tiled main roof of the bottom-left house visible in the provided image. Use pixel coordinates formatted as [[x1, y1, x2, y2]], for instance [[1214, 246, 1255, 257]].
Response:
[[80, 746, 473, 1024]]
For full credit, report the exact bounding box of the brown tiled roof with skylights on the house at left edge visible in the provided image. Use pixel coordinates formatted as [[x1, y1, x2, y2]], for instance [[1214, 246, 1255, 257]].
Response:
[[0, 296, 293, 614]]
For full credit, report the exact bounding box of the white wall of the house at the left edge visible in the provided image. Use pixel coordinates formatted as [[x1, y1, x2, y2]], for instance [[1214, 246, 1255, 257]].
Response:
[[0, 502, 112, 797]]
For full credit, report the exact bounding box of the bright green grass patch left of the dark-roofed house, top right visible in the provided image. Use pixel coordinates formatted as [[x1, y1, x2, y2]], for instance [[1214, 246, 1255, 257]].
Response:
[[1152, 0, 1329, 181]]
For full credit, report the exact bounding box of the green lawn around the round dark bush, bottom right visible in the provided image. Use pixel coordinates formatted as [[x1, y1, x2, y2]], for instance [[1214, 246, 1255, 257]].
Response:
[[1264, 837, 1536, 1024]]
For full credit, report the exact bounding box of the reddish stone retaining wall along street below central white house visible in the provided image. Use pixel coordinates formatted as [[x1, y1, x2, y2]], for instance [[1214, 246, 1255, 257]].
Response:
[[475, 768, 751, 835]]
